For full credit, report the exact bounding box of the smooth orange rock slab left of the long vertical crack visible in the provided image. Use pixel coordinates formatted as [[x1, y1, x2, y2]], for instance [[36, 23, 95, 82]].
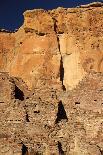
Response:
[[8, 34, 60, 88]]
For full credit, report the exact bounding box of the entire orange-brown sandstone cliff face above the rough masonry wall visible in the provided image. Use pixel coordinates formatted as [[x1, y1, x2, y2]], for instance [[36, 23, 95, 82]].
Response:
[[0, 3, 103, 89]]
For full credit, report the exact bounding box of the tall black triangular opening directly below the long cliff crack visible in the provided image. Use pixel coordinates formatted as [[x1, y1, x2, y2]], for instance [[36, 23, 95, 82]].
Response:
[[56, 101, 68, 123]]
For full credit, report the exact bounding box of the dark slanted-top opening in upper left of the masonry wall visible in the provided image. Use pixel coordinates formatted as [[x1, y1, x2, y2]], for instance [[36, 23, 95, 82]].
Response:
[[14, 85, 24, 101]]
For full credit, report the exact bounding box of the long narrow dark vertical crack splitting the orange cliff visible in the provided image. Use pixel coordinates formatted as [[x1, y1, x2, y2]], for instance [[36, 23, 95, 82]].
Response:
[[53, 18, 66, 91]]
